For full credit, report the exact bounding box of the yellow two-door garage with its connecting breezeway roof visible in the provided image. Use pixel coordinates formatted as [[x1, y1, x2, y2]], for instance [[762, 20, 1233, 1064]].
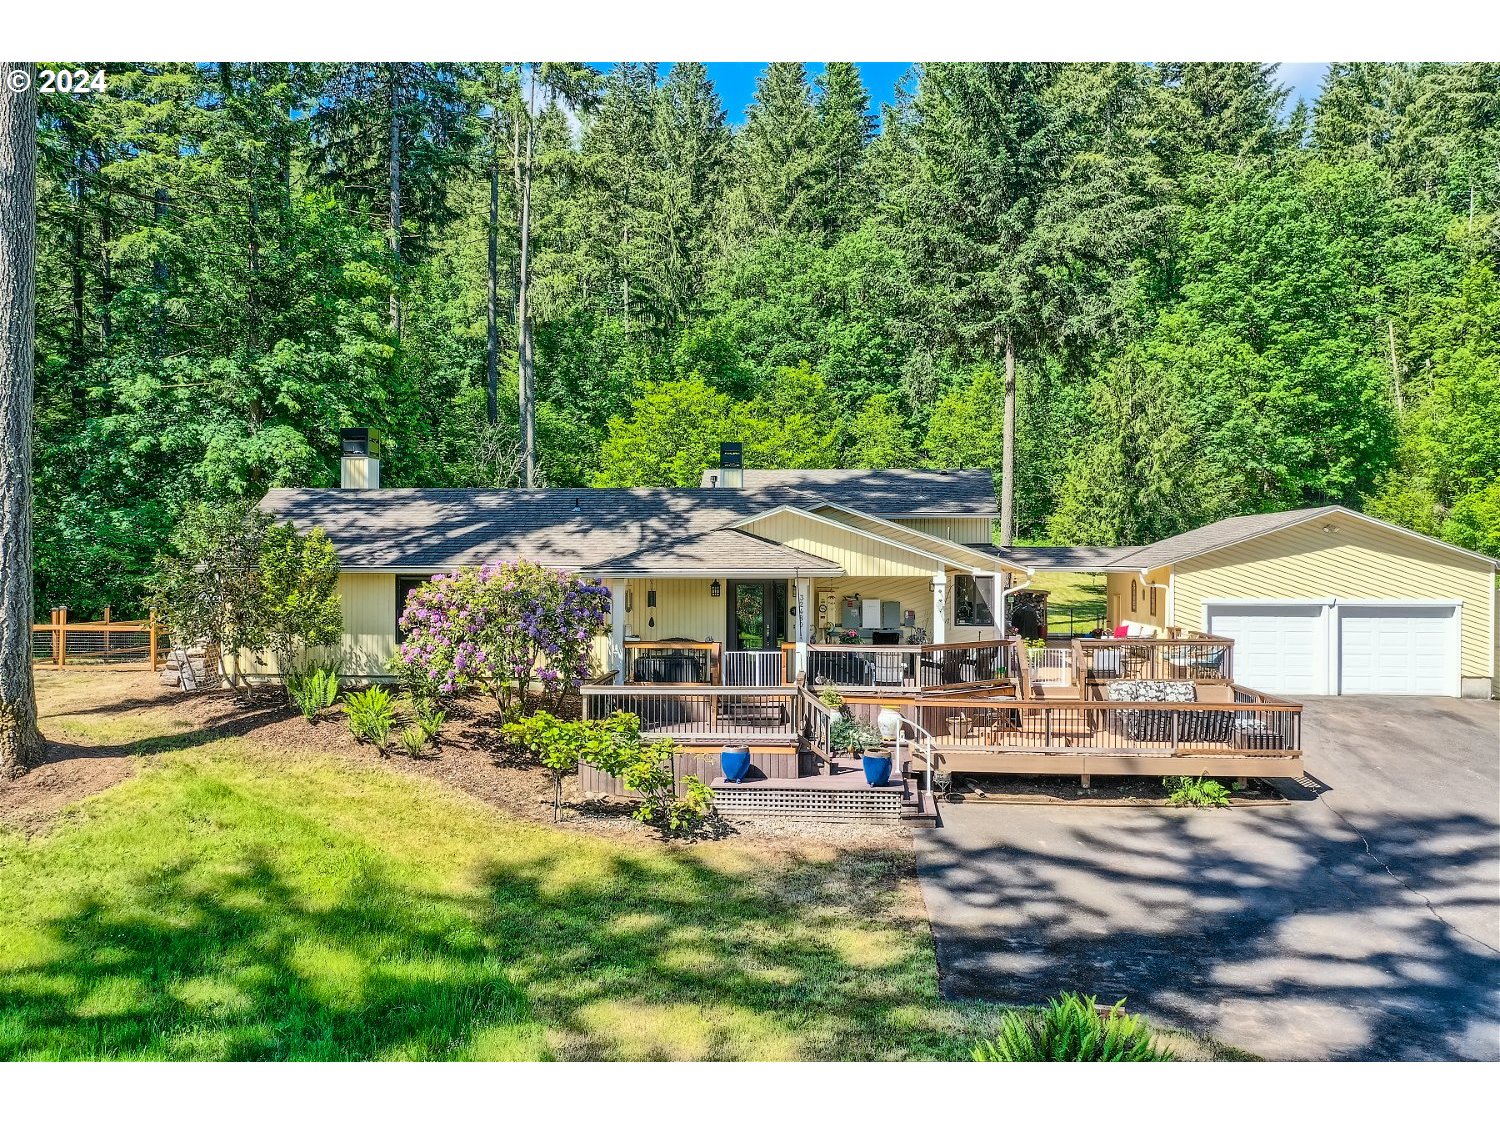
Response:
[[996, 506, 1497, 698]]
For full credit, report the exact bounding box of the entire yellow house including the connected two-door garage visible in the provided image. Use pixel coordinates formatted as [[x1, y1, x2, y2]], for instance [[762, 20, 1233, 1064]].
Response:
[[245, 431, 1497, 696]]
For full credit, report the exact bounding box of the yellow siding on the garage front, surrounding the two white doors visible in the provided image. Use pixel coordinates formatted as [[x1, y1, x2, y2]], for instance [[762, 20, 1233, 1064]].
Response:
[[1176, 515, 1496, 677]]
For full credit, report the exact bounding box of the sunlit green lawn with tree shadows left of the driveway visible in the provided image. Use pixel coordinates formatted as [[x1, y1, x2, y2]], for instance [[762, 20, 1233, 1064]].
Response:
[[0, 678, 999, 1059]]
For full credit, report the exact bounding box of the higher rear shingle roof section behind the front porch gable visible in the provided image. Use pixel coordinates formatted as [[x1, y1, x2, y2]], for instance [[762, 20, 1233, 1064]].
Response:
[[702, 470, 996, 516]]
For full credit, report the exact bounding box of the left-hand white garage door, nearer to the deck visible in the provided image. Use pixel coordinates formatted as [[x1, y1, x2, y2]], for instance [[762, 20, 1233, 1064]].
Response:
[[1208, 603, 1328, 696]]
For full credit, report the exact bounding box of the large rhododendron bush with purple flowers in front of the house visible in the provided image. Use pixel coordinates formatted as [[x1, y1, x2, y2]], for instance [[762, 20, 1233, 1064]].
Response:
[[393, 561, 609, 710]]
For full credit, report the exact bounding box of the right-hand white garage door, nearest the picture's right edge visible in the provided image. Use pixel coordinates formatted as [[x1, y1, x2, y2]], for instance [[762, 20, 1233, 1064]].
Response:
[[1338, 606, 1458, 696]]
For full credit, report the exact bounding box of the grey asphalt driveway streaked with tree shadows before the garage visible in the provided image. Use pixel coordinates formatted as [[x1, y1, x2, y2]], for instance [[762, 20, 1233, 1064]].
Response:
[[917, 698, 1500, 1059]]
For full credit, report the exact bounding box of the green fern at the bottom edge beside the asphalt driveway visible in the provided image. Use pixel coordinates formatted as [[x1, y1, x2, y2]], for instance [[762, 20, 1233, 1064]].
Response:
[[974, 992, 1173, 1062]]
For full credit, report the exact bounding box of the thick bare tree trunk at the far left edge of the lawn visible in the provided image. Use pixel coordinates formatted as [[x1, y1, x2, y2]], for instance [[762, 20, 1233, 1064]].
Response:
[[0, 63, 44, 777]]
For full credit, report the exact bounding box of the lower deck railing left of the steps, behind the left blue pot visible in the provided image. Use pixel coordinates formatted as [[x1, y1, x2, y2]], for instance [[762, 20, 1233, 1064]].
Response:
[[582, 684, 801, 743]]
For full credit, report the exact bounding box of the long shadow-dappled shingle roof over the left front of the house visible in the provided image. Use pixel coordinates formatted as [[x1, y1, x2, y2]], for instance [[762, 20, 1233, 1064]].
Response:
[[261, 489, 839, 573]]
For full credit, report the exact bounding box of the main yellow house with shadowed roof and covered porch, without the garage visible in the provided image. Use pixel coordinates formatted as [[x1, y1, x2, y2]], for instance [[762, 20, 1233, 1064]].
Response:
[[246, 440, 1025, 684]]
